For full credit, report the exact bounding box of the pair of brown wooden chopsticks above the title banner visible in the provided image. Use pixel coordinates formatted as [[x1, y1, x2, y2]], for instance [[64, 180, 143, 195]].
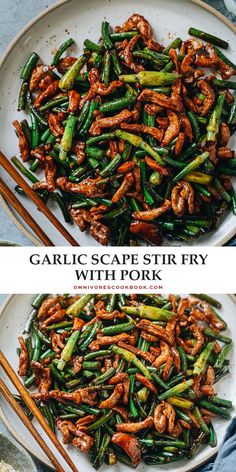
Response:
[[0, 151, 79, 246]]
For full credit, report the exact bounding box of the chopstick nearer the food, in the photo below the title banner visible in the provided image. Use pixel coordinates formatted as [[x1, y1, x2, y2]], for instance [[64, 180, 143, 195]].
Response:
[[0, 351, 78, 472]]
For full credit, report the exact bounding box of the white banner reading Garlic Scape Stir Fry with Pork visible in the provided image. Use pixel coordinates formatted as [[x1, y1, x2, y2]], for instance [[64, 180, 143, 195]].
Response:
[[0, 247, 236, 293]]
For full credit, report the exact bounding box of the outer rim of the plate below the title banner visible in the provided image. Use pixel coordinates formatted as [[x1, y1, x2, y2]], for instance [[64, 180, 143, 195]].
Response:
[[0, 294, 236, 472]]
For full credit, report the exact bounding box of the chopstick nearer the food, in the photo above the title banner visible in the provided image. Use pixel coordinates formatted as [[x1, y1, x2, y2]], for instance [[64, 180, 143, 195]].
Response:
[[0, 151, 79, 246]]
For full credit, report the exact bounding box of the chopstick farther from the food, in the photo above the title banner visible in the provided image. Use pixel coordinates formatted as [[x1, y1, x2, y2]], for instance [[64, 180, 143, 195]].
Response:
[[0, 178, 54, 246]]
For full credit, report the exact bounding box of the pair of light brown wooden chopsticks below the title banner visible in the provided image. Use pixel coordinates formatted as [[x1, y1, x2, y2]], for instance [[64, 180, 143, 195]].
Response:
[[0, 351, 78, 472]]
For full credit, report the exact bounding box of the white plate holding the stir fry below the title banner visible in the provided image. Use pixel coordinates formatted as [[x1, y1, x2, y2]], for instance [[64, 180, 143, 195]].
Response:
[[0, 295, 236, 472]]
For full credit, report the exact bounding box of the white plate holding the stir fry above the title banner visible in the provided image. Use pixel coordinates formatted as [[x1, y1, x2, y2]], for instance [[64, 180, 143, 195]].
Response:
[[0, 0, 236, 246]]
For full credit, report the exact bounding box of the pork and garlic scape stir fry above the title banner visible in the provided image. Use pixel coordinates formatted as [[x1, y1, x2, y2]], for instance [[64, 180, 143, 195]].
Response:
[[13, 14, 236, 246]]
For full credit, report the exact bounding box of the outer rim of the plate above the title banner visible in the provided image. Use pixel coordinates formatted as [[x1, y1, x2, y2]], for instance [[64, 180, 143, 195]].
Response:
[[0, 0, 236, 246]]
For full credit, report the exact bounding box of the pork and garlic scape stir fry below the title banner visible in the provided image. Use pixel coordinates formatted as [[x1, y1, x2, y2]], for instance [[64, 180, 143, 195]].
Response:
[[18, 294, 232, 469]]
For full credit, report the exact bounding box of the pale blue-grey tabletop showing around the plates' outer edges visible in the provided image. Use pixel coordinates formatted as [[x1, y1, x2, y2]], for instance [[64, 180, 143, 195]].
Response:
[[0, 0, 235, 472]]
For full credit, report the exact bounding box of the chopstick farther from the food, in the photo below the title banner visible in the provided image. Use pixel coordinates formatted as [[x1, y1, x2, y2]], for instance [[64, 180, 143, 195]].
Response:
[[0, 379, 64, 472]]
